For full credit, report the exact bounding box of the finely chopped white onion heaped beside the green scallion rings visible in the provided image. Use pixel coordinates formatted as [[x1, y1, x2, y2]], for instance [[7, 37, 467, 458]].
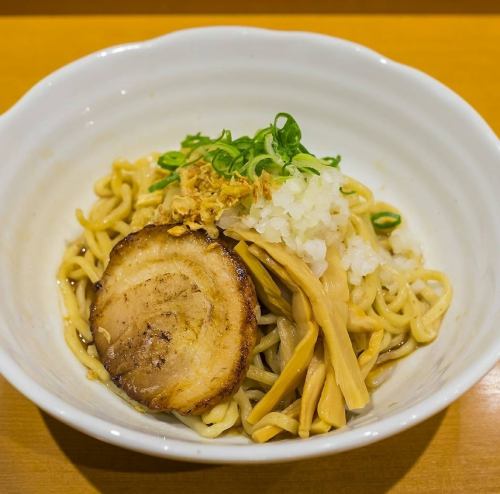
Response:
[[218, 167, 420, 282]]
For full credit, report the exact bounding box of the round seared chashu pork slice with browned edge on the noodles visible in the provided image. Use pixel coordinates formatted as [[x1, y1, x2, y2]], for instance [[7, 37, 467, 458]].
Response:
[[90, 226, 257, 414]]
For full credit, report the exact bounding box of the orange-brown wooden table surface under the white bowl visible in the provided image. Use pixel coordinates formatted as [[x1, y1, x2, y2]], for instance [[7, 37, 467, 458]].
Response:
[[0, 15, 500, 494]]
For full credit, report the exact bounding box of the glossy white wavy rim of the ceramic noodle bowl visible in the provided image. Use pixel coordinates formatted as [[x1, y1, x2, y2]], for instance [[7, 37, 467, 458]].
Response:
[[0, 26, 500, 463]]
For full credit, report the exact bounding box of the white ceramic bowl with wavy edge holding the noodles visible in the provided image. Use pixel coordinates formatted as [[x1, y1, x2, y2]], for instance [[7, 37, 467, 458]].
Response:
[[0, 27, 500, 463]]
